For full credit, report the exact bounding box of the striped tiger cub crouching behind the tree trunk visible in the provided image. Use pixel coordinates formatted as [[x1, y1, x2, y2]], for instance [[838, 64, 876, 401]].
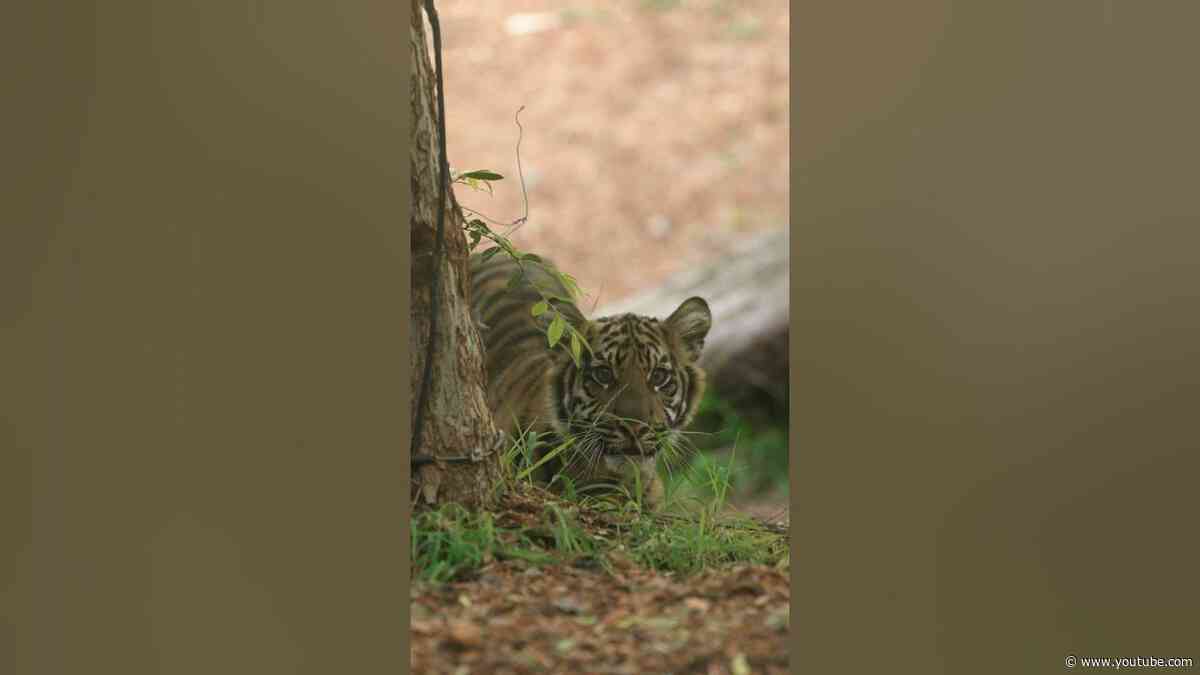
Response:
[[470, 253, 713, 508]]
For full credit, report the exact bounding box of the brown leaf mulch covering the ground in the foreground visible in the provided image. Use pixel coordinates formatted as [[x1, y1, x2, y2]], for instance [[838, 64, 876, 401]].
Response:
[[410, 562, 791, 675]]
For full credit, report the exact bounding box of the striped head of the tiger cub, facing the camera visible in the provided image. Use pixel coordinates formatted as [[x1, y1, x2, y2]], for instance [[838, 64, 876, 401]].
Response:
[[551, 298, 713, 471]]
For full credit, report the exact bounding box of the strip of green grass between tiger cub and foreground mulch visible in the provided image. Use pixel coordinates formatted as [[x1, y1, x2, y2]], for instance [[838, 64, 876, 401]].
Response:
[[412, 438, 787, 584]]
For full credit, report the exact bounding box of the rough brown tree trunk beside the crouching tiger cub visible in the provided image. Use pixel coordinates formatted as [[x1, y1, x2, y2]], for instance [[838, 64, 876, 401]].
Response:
[[409, 0, 499, 507]]
